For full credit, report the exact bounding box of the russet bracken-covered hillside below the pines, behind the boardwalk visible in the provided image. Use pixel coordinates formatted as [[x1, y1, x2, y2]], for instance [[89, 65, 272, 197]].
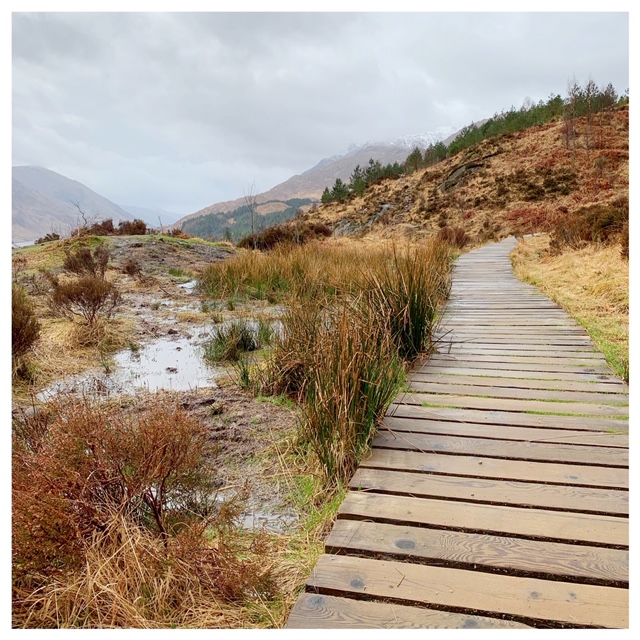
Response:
[[305, 105, 629, 242]]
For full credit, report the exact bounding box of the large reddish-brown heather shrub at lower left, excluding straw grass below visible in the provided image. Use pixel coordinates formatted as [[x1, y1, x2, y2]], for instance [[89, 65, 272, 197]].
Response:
[[12, 398, 218, 575]]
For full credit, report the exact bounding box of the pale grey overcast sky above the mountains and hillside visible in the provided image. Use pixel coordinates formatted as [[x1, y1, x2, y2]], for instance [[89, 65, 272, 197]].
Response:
[[12, 12, 629, 214]]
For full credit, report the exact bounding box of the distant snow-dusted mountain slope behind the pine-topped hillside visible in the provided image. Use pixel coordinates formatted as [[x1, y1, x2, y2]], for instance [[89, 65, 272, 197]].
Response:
[[175, 127, 458, 228]]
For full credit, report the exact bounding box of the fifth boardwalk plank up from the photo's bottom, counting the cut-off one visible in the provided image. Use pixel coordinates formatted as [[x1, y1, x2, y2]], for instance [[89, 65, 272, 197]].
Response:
[[349, 467, 629, 517]]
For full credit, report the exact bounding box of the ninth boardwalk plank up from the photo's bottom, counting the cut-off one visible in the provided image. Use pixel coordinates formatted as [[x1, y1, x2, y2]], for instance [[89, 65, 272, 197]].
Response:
[[387, 403, 629, 433]]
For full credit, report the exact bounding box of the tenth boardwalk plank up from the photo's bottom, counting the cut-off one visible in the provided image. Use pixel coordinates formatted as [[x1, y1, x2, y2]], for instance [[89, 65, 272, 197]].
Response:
[[394, 393, 629, 418]]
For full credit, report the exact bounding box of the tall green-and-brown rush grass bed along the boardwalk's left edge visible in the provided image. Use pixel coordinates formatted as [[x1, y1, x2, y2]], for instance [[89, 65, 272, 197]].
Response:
[[221, 240, 451, 486]]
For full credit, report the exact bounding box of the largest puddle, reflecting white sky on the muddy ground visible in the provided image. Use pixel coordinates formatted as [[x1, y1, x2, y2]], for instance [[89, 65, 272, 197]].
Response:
[[38, 337, 224, 400]]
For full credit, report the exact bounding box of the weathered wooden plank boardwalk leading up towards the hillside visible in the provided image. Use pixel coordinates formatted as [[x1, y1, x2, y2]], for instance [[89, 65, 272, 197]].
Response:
[[287, 239, 629, 628]]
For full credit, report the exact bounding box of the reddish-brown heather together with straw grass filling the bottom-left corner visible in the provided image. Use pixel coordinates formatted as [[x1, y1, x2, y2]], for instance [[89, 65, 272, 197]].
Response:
[[11, 398, 281, 628]]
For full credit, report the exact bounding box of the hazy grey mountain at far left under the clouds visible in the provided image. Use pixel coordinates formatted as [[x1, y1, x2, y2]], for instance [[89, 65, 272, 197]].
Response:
[[11, 167, 135, 242]]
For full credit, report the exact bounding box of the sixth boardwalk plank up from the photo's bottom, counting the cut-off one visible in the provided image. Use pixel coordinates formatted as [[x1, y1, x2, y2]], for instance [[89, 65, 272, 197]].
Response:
[[360, 449, 629, 490]]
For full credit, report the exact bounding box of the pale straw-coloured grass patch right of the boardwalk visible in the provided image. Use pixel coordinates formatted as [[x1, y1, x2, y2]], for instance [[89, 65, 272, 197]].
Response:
[[512, 235, 629, 380]]
